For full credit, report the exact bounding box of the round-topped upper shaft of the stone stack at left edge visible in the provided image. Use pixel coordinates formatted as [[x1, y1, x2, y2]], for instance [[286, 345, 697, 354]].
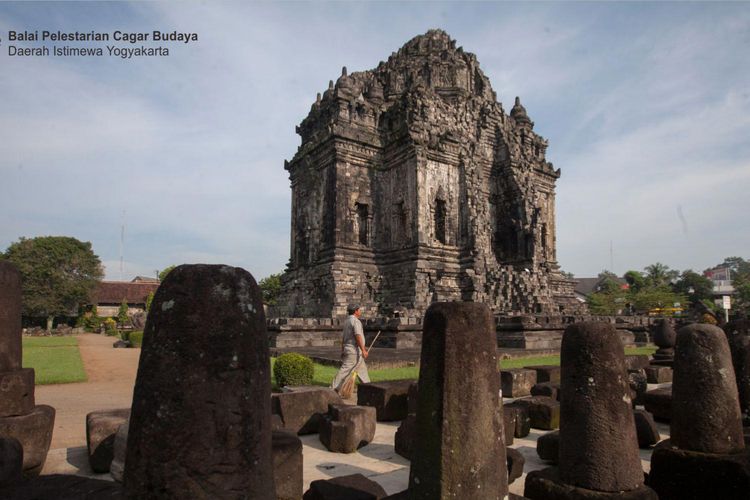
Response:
[[0, 260, 21, 372]]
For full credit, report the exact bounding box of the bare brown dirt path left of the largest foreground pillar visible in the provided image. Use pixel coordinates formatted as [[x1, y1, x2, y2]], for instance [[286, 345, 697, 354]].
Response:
[[35, 333, 141, 450]]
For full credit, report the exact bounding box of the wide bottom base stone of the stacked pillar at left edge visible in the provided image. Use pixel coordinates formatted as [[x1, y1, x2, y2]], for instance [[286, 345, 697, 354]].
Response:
[[0, 405, 55, 478]]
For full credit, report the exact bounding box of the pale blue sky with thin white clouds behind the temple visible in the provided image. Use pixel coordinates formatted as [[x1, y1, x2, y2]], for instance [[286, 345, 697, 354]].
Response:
[[0, 2, 750, 280]]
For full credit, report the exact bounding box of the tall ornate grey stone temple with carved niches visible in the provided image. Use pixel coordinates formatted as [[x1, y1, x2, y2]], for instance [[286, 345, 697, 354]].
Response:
[[279, 30, 581, 318]]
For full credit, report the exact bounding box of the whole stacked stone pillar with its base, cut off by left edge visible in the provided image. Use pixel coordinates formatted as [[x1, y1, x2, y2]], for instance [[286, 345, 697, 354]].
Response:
[[0, 260, 55, 477]]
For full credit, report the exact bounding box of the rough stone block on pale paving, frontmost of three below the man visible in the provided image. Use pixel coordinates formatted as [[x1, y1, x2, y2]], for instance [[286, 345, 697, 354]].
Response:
[[319, 404, 377, 453]]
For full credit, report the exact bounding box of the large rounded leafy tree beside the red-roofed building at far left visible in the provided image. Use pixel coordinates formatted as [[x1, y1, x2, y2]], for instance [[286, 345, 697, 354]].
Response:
[[3, 236, 104, 330]]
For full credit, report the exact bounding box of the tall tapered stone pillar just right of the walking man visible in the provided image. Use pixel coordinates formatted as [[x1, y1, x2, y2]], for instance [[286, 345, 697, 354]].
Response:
[[409, 302, 508, 500]]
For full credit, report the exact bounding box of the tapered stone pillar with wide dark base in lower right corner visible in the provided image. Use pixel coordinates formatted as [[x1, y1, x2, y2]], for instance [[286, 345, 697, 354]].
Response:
[[649, 324, 750, 500]]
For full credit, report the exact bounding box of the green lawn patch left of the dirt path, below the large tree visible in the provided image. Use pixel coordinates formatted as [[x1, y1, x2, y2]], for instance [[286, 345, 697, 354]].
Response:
[[23, 337, 86, 385]]
